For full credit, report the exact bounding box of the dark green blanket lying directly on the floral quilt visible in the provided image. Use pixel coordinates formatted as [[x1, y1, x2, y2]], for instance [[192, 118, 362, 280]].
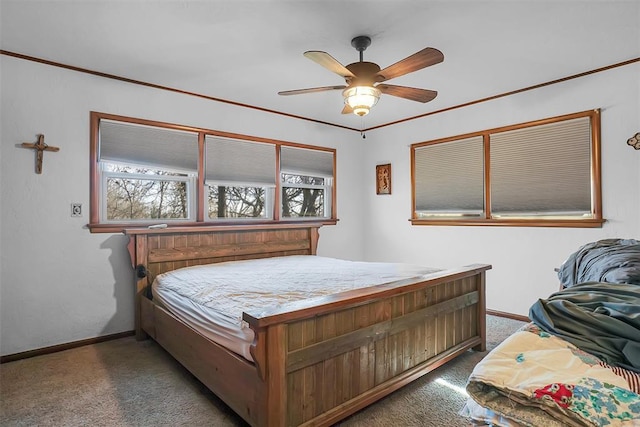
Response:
[[529, 282, 640, 372]]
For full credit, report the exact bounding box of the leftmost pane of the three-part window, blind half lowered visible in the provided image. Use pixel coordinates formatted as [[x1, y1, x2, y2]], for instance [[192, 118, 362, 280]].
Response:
[[98, 120, 198, 223]]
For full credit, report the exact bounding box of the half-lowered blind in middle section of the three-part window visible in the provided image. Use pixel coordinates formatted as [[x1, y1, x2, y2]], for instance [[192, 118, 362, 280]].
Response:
[[205, 135, 276, 186]]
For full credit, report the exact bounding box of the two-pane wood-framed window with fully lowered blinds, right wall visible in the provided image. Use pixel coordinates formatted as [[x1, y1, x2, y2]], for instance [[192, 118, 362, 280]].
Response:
[[411, 110, 603, 227]]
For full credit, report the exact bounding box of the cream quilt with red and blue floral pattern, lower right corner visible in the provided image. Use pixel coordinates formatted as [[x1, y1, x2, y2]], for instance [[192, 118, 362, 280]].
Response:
[[467, 323, 640, 427]]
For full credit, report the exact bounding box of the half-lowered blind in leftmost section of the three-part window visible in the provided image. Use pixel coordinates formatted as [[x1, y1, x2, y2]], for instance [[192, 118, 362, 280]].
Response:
[[98, 120, 198, 172]]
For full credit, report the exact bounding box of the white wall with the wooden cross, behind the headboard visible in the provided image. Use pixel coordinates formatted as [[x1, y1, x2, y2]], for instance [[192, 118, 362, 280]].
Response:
[[0, 55, 363, 355]]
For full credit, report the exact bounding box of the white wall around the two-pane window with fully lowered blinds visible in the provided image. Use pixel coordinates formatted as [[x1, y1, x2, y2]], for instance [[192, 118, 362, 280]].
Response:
[[364, 63, 640, 315]]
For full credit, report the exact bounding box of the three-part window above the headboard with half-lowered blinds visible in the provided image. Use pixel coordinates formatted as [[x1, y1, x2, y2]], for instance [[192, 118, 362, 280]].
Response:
[[89, 113, 336, 232]]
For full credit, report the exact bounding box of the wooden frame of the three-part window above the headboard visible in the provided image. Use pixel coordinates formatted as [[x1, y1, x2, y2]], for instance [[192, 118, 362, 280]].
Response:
[[88, 111, 338, 233]]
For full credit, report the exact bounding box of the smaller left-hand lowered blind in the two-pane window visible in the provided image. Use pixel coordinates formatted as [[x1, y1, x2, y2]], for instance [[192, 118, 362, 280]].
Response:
[[414, 136, 484, 215]]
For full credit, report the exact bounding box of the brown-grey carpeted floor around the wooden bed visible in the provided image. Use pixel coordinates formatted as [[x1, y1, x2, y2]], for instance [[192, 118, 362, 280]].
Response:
[[0, 316, 523, 427]]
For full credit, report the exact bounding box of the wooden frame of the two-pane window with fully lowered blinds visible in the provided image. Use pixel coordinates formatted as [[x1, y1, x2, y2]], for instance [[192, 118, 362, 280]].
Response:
[[410, 109, 605, 228]]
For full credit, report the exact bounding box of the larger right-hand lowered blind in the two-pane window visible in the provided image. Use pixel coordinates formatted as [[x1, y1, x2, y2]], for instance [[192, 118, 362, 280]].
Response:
[[490, 117, 591, 215]]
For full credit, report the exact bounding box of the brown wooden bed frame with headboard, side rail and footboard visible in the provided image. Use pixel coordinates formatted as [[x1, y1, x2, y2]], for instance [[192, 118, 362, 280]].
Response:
[[125, 223, 491, 427]]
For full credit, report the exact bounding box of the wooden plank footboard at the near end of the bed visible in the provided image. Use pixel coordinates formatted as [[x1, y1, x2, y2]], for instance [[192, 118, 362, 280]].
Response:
[[244, 265, 490, 426]]
